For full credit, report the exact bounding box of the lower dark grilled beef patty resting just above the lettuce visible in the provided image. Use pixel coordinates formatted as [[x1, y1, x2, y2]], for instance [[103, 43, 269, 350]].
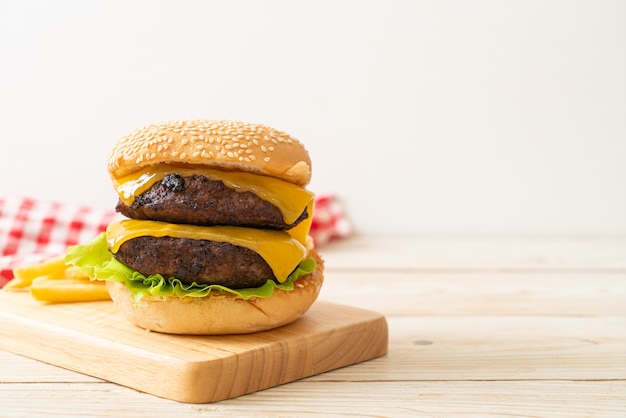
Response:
[[115, 236, 275, 289]]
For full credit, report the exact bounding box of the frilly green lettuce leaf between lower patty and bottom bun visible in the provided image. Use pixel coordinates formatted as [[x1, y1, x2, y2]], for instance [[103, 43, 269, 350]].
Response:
[[65, 233, 315, 301]]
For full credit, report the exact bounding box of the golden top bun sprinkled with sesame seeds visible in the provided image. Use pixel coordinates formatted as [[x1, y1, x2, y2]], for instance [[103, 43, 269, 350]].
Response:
[[106, 119, 311, 187]]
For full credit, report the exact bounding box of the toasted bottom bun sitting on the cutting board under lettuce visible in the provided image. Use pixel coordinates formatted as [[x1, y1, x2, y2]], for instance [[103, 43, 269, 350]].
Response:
[[107, 250, 324, 335]]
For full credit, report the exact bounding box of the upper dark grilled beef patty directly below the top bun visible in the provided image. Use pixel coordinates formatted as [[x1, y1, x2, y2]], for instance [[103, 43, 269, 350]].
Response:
[[115, 174, 309, 230]]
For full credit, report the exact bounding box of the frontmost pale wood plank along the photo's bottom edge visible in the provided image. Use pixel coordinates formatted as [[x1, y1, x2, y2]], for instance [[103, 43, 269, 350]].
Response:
[[0, 379, 626, 418]]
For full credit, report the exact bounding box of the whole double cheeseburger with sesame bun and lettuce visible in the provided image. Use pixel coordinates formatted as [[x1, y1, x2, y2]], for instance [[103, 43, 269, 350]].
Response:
[[66, 120, 323, 334]]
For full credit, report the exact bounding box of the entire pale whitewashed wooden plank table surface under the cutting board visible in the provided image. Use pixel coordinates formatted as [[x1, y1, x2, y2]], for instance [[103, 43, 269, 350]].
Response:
[[0, 237, 626, 417]]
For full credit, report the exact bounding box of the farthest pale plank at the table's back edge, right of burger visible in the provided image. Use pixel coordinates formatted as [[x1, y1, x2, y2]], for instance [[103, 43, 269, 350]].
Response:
[[320, 235, 626, 272]]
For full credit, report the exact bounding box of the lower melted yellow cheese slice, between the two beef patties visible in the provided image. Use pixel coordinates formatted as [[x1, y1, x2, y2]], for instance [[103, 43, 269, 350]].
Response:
[[106, 219, 307, 283]]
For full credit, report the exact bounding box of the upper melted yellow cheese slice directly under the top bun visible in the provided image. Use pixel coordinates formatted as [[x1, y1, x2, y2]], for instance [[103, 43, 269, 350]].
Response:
[[114, 164, 314, 224]]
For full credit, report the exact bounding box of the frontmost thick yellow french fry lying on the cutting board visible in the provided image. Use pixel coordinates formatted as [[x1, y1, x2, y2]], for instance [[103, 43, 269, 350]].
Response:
[[30, 276, 111, 303]]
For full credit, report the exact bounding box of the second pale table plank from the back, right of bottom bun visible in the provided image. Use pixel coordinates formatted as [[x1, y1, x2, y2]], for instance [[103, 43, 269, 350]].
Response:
[[319, 271, 626, 316]]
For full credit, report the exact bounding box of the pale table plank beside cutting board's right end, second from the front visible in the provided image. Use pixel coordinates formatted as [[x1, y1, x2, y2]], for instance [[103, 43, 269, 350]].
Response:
[[6, 316, 626, 383]]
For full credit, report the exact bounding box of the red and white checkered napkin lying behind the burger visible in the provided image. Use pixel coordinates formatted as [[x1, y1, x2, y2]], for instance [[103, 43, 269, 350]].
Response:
[[0, 195, 350, 288]]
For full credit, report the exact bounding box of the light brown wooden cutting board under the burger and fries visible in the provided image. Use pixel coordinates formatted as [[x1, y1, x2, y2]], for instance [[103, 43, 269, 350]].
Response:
[[0, 290, 388, 403]]
